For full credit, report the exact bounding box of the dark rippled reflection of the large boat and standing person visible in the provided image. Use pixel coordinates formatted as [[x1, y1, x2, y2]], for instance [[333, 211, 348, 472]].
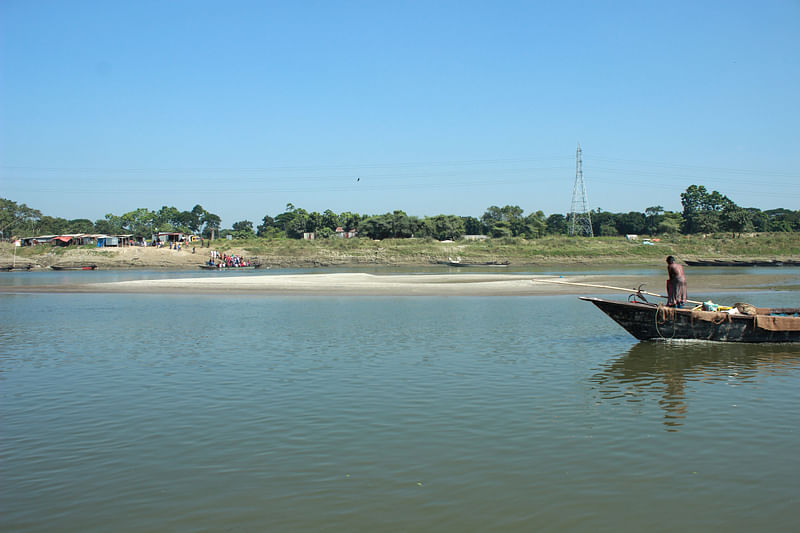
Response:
[[589, 342, 800, 431]]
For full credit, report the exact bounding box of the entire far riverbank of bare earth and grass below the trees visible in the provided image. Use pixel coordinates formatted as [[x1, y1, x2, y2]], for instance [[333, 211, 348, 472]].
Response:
[[0, 233, 800, 270]]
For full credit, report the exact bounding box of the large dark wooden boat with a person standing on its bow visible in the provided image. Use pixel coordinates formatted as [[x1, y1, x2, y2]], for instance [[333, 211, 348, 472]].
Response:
[[581, 297, 800, 342]]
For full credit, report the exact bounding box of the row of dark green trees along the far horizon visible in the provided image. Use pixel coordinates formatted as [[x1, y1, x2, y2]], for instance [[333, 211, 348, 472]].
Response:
[[0, 185, 800, 240]]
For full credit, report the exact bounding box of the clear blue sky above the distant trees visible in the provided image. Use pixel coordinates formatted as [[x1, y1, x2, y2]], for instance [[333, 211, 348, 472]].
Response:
[[0, 0, 800, 227]]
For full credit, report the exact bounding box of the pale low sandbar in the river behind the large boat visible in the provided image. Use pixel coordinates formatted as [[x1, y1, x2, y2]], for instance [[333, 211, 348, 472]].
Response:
[[0, 273, 797, 298]]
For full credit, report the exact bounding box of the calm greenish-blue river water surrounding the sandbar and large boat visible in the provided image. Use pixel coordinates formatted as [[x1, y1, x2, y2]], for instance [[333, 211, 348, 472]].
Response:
[[0, 272, 800, 532]]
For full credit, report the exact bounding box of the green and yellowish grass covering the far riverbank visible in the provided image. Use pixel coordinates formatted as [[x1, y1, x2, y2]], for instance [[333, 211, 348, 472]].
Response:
[[0, 233, 800, 265]]
